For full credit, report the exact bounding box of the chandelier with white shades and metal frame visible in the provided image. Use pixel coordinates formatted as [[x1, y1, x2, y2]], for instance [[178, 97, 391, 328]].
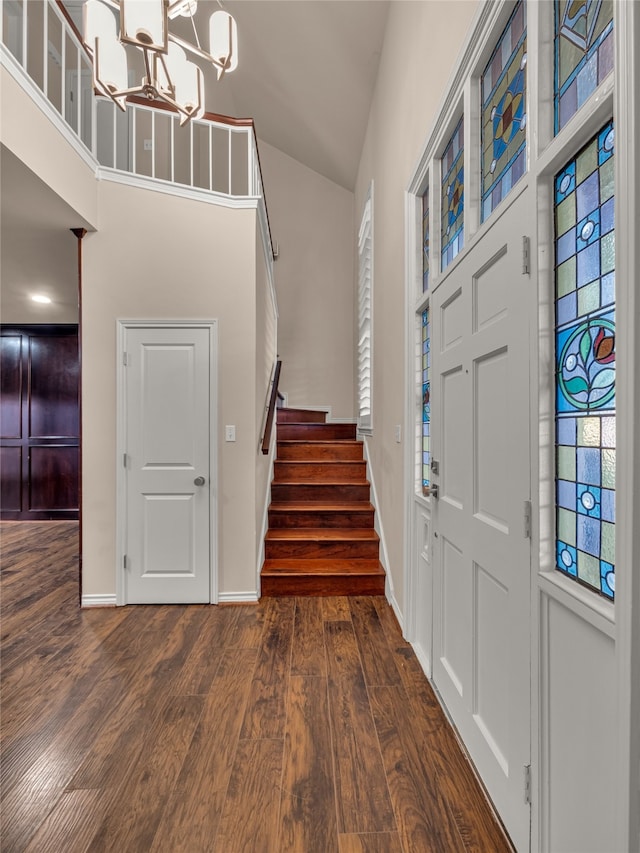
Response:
[[83, 0, 238, 126]]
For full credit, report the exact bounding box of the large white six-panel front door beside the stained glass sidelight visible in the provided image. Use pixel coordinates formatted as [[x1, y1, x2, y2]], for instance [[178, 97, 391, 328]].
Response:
[[431, 188, 535, 850]]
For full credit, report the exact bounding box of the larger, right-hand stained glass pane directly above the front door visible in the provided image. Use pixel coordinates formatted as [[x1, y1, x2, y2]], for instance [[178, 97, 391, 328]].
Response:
[[481, 0, 527, 220]]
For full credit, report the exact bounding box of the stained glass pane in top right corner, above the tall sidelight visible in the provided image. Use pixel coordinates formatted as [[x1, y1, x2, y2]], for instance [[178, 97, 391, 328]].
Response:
[[553, 0, 613, 133]]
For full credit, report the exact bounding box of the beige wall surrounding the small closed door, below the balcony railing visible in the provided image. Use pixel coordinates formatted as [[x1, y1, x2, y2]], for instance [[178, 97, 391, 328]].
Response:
[[82, 181, 261, 595]]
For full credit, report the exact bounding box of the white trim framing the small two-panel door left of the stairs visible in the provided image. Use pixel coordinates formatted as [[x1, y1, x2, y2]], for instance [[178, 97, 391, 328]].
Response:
[[115, 318, 218, 606]]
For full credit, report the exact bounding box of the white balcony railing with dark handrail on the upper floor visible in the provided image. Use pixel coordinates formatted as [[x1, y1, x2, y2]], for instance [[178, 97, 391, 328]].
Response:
[[2, 0, 273, 256]]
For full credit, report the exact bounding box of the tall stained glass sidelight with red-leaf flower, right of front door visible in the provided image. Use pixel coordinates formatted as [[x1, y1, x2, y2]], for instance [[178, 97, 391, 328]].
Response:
[[555, 122, 616, 599]]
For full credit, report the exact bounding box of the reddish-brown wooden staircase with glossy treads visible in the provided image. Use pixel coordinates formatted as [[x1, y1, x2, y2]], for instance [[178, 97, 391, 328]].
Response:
[[261, 409, 385, 597]]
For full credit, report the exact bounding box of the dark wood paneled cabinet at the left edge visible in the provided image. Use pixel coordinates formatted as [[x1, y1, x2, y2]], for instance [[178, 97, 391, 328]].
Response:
[[0, 325, 80, 520]]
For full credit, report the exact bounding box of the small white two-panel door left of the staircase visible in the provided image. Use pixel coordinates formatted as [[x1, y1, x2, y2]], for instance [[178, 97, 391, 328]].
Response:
[[122, 326, 212, 604]]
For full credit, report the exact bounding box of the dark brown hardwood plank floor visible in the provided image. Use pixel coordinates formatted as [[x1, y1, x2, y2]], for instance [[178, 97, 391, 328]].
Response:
[[0, 522, 511, 853]]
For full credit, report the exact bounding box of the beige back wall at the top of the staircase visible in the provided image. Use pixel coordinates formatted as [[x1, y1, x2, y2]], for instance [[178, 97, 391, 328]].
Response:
[[260, 142, 355, 418]]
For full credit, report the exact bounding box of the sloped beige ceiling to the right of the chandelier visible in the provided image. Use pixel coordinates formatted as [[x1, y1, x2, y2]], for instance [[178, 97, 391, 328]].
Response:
[[220, 0, 389, 189]]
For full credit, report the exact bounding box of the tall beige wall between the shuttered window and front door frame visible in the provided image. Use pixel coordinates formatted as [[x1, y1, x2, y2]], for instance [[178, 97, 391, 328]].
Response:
[[356, 0, 478, 612]]
